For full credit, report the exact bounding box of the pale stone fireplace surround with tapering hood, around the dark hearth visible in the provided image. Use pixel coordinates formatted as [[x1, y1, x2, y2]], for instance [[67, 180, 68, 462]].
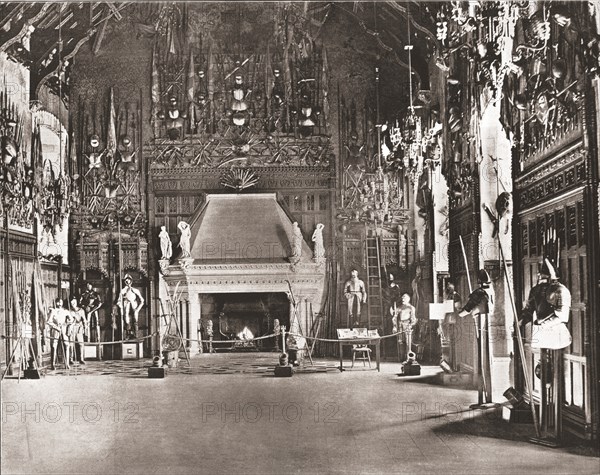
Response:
[[159, 193, 325, 354]]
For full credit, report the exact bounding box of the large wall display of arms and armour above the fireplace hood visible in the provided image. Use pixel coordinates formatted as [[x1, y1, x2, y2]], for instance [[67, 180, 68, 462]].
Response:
[[151, 5, 334, 174]]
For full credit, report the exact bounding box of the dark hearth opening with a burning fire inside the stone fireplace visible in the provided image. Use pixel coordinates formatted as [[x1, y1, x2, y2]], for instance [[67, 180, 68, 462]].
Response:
[[201, 292, 290, 352]]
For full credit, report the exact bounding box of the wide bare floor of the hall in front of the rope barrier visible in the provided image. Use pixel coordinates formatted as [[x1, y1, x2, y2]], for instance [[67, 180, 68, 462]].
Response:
[[1, 354, 600, 474]]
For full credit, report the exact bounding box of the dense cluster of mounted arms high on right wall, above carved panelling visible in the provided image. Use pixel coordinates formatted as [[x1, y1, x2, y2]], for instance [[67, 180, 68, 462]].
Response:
[[496, 3, 593, 168]]
